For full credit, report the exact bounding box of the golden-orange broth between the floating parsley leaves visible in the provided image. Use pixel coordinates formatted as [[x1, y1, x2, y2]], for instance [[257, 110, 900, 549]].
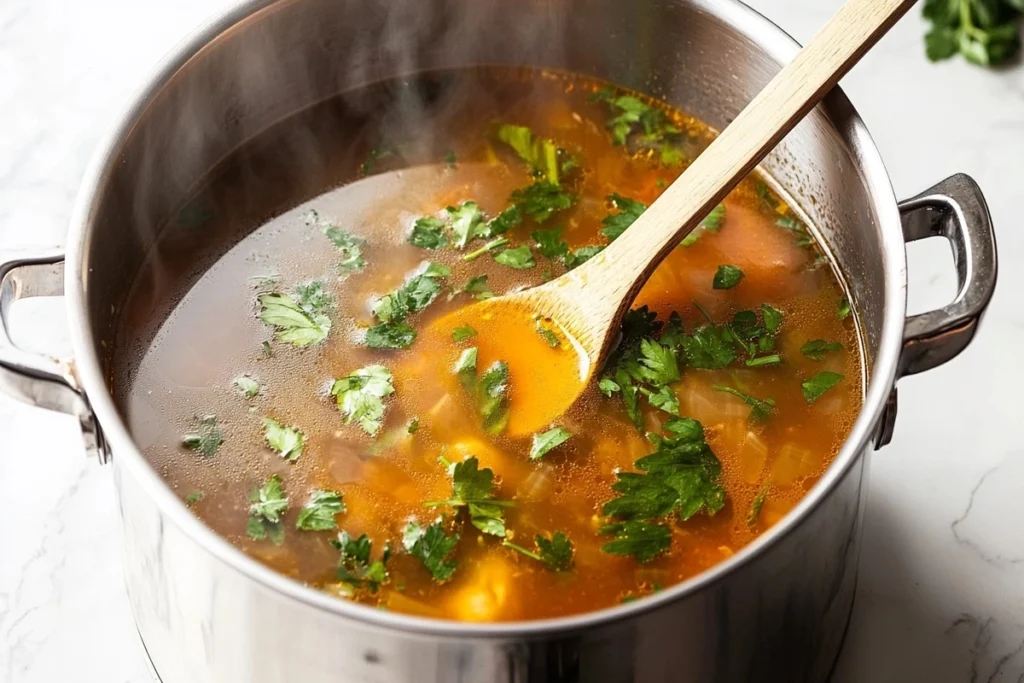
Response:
[[116, 69, 862, 621]]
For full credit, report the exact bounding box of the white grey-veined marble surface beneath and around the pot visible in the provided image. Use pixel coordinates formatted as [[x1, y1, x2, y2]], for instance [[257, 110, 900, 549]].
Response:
[[0, 0, 1024, 683]]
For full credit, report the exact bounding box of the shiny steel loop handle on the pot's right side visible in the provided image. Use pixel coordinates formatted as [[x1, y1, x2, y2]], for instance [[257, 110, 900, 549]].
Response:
[[897, 173, 996, 377]]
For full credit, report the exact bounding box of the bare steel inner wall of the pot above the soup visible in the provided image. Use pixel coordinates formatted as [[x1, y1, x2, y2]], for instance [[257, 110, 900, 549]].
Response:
[[81, 0, 886, 409]]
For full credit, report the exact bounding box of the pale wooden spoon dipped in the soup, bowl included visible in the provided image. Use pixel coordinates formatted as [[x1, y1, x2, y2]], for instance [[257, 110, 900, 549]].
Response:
[[435, 0, 913, 435]]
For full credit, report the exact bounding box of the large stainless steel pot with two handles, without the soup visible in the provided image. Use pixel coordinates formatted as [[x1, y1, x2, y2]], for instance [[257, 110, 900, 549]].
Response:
[[0, 0, 996, 683]]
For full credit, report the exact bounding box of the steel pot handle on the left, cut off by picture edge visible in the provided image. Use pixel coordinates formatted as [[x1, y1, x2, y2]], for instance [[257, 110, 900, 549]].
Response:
[[0, 249, 109, 462]]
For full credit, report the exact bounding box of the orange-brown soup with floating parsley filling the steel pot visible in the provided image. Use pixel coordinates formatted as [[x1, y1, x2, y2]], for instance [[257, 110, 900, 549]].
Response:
[[116, 68, 863, 622]]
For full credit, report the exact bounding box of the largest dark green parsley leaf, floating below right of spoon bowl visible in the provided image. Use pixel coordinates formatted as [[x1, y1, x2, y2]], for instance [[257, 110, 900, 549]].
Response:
[[601, 418, 725, 562]]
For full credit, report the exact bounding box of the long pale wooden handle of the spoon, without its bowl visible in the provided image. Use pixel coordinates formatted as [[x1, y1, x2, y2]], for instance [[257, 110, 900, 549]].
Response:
[[569, 0, 913, 319]]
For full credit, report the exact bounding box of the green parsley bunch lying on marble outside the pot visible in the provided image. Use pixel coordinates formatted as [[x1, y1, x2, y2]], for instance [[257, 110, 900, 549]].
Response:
[[924, 0, 1024, 67]]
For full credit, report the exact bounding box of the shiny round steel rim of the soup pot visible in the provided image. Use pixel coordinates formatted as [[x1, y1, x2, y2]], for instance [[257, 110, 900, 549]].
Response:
[[59, 0, 906, 639]]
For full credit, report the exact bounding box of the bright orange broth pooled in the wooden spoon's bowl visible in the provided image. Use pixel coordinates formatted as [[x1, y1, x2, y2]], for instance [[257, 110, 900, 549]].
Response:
[[417, 301, 590, 437]]
